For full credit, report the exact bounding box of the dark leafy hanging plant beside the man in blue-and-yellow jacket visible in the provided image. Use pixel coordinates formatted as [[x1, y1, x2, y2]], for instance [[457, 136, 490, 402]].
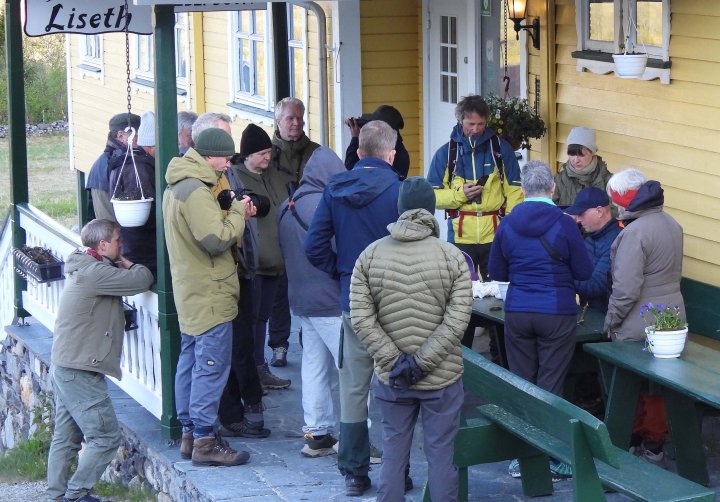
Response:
[[485, 94, 546, 150]]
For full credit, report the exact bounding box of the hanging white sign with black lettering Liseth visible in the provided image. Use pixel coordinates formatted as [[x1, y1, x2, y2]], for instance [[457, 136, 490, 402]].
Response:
[[25, 0, 153, 37]]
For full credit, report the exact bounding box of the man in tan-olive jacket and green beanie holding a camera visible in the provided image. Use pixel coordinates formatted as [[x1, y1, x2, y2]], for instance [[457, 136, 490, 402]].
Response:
[[163, 128, 255, 466]]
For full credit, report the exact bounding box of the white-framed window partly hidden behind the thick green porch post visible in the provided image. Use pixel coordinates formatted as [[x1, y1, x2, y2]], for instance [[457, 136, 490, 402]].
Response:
[[131, 12, 188, 94]]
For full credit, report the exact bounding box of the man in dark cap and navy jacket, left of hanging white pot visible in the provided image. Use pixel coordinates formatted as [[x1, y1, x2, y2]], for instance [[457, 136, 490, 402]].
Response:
[[85, 113, 140, 221]]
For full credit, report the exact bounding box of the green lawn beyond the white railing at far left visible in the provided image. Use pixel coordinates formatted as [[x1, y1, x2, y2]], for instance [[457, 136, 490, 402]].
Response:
[[0, 134, 77, 228]]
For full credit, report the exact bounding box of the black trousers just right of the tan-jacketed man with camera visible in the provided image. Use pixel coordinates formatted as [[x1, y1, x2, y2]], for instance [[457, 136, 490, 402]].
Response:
[[218, 278, 262, 425]]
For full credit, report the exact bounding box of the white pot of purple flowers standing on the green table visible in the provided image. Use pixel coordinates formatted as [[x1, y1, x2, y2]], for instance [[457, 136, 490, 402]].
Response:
[[640, 303, 688, 359]]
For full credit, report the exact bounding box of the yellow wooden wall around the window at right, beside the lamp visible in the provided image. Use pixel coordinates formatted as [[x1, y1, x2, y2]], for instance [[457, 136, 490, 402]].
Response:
[[551, 0, 720, 286]]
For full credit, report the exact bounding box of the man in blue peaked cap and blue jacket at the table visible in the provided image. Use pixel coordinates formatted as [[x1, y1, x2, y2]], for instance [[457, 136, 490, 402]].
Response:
[[565, 187, 621, 312]]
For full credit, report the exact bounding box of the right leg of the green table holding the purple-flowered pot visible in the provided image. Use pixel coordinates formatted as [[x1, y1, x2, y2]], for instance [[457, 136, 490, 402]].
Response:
[[662, 387, 710, 486]]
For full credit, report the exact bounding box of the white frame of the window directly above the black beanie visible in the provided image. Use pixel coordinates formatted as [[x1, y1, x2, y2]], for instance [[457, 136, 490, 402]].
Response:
[[228, 4, 275, 111]]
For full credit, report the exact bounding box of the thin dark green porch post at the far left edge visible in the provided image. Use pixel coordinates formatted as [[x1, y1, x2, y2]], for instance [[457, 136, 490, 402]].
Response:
[[5, 0, 30, 317]]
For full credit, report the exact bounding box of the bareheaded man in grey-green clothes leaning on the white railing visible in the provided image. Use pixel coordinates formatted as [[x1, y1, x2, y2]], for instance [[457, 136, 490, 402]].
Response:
[[47, 220, 155, 502]]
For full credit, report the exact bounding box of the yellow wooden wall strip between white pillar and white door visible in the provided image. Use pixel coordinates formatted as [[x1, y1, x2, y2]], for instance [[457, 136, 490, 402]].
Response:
[[360, 0, 423, 176]]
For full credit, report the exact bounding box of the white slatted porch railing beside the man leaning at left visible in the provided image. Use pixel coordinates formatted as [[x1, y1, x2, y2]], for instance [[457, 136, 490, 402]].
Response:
[[6, 204, 162, 418]]
